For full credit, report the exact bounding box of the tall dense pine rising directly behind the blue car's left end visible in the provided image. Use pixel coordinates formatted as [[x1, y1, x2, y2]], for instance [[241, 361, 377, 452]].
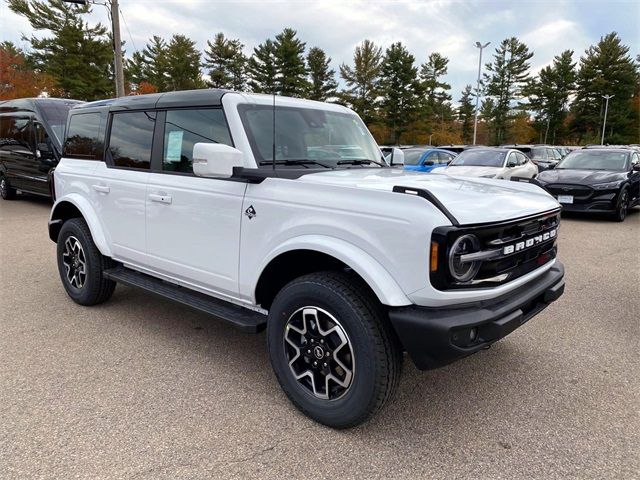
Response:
[[380, 42, 419, 144]]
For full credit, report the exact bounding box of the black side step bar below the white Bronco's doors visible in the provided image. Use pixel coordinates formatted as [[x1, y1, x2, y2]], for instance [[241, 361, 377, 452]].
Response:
[[104, 266, 267, 333]]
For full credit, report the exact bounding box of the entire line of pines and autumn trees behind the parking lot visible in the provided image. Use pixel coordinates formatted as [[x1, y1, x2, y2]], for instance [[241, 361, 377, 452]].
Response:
[[5, 0, 640, 145]]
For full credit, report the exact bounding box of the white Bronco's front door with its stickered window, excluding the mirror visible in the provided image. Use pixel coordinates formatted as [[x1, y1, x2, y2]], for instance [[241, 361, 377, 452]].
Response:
[[146, 107, 246, 297]]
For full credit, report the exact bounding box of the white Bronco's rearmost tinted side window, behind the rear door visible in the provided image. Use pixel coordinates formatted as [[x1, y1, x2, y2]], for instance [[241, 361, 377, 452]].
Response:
[[64, 112, 104, 161]]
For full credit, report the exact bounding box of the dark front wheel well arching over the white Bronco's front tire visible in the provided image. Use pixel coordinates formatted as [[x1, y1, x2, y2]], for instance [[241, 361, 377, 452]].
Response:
[[256, 250, 377, 310]]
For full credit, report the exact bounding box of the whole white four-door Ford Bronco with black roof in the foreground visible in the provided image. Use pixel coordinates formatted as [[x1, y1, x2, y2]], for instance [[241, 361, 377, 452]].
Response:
[[49, 90, 564, 428]]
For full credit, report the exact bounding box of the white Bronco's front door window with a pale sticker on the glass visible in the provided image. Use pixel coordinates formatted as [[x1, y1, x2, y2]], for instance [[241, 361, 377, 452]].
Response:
[[162, 109, 232, 173]]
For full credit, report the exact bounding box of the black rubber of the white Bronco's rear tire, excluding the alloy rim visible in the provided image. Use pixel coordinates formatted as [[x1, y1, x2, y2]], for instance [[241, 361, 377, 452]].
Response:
[[56, 218, 116, 306]]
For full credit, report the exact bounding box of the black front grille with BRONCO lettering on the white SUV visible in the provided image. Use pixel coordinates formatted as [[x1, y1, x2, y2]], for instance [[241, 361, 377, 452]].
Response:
[[431, 210, 560, 290]]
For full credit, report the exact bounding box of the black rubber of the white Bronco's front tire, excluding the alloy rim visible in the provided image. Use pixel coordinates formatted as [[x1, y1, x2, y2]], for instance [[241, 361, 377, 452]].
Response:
[[267, 271, 402, 429]]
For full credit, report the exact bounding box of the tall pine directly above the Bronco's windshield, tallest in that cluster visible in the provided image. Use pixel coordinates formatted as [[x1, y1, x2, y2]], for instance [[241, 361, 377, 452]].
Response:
[[274, 28, 308, 97]]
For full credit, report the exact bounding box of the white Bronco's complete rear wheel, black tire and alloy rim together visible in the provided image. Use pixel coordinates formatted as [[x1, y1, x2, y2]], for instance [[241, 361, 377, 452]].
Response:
[[57, 218, 116, 305]]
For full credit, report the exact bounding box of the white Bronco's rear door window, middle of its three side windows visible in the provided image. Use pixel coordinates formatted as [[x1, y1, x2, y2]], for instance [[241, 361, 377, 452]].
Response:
[[107, 112, 156, 170]]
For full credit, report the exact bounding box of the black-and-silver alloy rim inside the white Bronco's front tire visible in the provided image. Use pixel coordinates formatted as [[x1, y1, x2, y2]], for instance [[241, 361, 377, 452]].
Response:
[[284, 306, 355, 400]]
